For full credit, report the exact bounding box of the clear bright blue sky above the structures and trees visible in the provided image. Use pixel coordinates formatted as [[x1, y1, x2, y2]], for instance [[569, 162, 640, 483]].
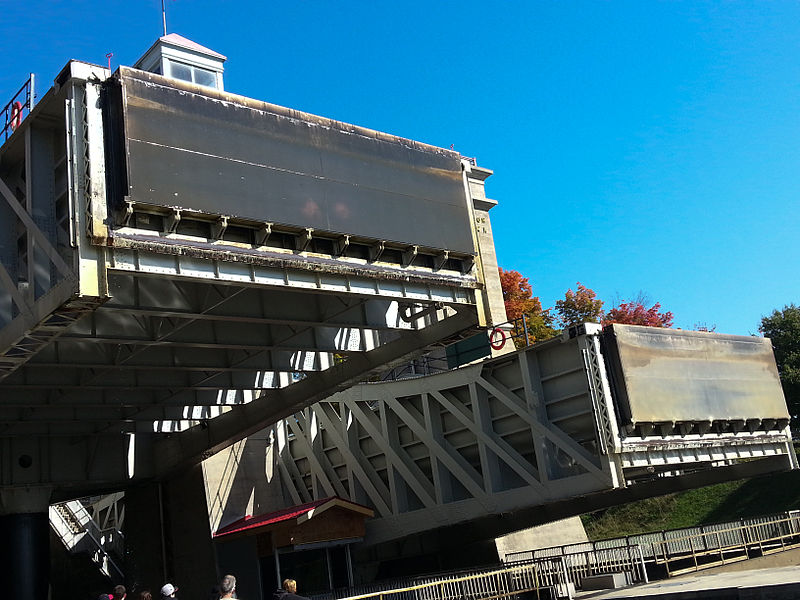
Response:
[[0, 0, 800, 334]]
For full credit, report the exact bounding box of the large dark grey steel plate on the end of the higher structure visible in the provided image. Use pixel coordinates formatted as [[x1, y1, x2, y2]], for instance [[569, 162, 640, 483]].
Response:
[[108, 68, 475, 254]]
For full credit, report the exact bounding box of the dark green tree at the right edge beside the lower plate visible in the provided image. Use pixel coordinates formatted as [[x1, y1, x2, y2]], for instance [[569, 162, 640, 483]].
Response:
[[758, 304, 800, 425]]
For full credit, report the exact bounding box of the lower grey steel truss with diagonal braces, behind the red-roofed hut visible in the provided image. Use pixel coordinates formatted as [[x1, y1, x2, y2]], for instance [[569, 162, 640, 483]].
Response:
[[273, 331, 796, 543]]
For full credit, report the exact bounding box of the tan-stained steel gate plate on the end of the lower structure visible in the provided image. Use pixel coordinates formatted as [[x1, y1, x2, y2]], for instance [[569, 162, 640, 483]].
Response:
[[603, 324, 789, 424]]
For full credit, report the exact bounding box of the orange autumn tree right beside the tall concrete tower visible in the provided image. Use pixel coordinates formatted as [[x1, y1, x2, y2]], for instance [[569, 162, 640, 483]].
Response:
[[500, 268, 557, 347]]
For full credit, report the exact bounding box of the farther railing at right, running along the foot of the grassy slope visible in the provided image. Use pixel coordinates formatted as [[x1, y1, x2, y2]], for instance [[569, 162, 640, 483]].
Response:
[[504, 511, 800, 576]]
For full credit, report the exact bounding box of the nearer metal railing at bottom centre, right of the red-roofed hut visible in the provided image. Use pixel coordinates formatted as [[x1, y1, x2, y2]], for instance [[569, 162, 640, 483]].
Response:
[[314, 546, 647, 600]]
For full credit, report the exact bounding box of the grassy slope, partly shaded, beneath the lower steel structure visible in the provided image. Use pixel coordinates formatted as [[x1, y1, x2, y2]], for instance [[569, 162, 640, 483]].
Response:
[[583, 471, 800, 540]]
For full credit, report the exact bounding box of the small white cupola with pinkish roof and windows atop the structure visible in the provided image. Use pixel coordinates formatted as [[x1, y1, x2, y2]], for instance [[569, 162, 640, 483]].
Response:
[[133, 33, 227, 90]]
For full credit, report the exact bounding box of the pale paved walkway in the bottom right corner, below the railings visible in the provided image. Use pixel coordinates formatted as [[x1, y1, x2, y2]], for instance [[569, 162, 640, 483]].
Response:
[[576, 566, 800, 600]]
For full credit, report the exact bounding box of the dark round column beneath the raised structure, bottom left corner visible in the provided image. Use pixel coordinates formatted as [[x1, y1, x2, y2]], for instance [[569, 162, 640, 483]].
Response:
[[0, 486, 52, 600]]
